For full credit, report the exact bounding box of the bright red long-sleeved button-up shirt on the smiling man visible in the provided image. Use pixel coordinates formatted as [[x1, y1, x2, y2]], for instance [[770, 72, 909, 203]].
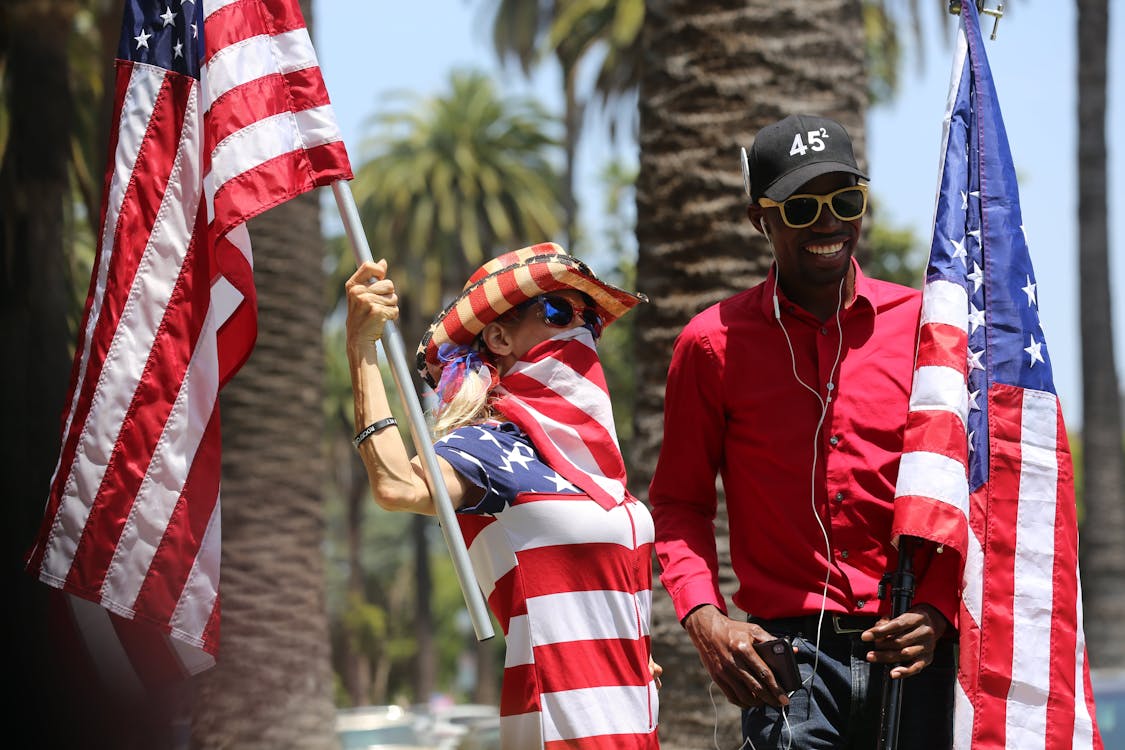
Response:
[[649, 264, 960, 624]]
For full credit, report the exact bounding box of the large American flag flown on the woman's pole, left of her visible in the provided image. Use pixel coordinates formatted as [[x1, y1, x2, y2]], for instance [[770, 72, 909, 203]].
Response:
[[27, 0, 352, 688]]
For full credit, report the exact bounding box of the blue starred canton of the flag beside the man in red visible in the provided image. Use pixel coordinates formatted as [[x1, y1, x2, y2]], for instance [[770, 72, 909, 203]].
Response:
[[927, 38, 1055, 488]]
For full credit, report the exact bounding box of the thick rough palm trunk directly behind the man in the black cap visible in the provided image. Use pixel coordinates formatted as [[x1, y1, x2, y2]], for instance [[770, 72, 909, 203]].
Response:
[[631, 0, 867, 750]]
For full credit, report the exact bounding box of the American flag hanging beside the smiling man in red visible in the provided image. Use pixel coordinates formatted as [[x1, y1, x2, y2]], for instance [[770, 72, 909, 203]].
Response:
[[893, 2, 1101, 750]]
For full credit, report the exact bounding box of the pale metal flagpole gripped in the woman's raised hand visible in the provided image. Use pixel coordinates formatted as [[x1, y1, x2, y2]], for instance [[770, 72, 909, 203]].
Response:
[[332, 180, 495, 641]]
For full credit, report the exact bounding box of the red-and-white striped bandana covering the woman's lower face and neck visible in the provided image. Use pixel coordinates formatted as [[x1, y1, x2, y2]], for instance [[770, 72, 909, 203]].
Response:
[[497, 328, 628, 510]]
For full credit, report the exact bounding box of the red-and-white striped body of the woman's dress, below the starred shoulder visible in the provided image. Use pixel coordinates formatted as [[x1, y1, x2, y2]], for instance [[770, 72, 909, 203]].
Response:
[[459, 494, 658, 750]]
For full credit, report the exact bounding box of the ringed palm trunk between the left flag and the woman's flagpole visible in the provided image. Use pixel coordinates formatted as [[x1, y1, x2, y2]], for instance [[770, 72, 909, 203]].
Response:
[[192, 184, 334, 750]]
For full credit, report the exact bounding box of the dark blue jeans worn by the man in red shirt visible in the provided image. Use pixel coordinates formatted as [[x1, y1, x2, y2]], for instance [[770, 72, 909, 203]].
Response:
[[743, 614, 957, 750]]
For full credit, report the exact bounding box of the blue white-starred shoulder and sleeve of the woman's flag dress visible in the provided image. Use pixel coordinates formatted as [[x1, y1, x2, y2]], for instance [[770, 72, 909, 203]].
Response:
[[434, 422, 582, 513]]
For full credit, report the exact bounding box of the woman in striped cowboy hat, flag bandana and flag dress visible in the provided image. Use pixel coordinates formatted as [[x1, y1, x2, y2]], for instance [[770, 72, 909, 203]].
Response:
[[347, 243, 660, 750]]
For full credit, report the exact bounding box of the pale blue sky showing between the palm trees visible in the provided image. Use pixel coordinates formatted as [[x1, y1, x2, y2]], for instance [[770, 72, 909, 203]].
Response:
[[314, 0, 1125, 428]]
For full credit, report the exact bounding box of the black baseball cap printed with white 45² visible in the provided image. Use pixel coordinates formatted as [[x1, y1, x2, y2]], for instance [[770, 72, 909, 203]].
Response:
[[747, 115, 867, 202]]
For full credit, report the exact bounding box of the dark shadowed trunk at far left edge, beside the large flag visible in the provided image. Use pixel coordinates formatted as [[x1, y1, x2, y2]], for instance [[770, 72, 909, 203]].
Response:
[[0, 0, 113, 748]]
